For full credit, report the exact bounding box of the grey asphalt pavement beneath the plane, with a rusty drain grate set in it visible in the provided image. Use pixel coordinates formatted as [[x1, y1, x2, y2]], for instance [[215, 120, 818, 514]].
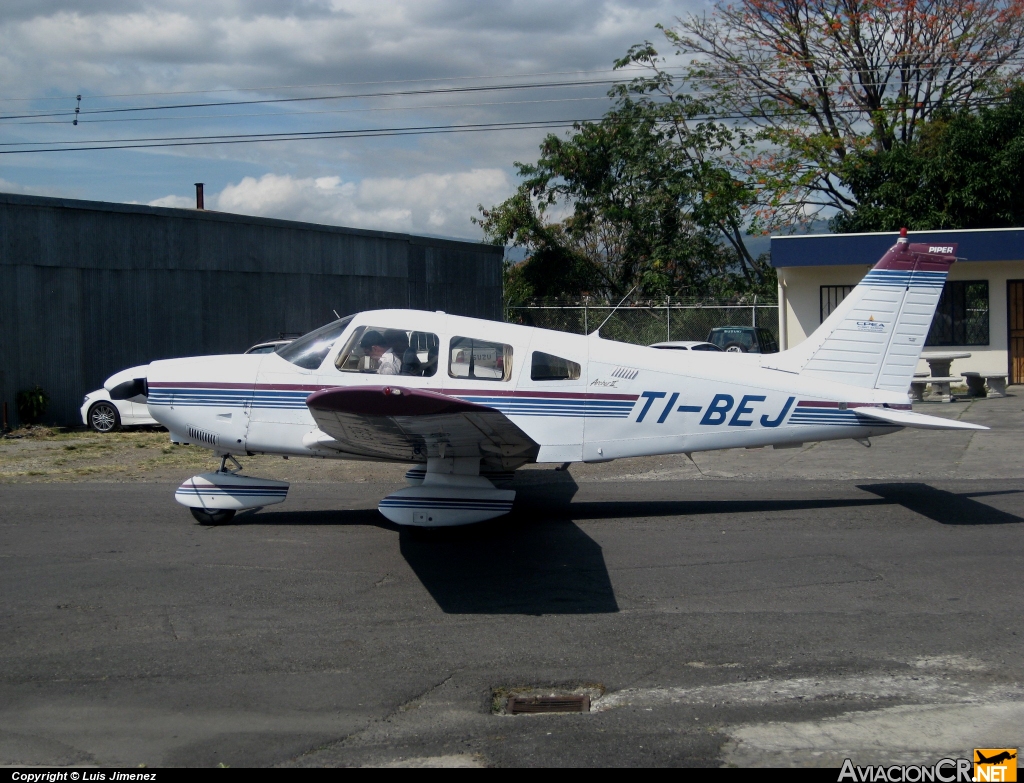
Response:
[[0, 397, 1024, 767]]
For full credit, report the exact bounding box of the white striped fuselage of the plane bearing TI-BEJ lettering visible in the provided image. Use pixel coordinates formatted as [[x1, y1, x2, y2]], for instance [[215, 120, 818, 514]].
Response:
[[148, 310, 909, 463]]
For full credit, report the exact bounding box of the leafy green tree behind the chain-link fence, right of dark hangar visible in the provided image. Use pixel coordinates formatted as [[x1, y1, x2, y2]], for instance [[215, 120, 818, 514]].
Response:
[[477, 75, 774, 297]]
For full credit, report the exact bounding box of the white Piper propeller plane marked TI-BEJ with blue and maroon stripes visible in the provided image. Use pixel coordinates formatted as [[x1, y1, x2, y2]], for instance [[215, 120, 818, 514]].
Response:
[[109, 232, 987, 527]]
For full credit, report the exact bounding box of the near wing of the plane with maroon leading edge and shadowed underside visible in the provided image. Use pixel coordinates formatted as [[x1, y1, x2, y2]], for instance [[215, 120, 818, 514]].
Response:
[[306, 386, 538, 463]]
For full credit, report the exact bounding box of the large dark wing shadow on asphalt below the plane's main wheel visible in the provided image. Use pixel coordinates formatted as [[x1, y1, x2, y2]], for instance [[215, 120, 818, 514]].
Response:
[[399, 472, 618, 615]]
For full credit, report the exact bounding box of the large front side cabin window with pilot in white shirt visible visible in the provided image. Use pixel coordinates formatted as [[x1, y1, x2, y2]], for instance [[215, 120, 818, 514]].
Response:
[[335, 327, 440, 378]]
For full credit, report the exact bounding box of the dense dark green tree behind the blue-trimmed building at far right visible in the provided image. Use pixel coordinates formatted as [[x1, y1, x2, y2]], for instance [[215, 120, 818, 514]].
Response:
[[833, 86, 1024, 231]]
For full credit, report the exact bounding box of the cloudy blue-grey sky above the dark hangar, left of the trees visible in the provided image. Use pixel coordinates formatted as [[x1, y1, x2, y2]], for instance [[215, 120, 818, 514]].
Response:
[[0, 0, 701, 238]]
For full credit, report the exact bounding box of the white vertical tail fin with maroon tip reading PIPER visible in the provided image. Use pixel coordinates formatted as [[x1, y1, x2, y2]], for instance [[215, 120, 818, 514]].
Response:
[[763, 230, 956, 392]]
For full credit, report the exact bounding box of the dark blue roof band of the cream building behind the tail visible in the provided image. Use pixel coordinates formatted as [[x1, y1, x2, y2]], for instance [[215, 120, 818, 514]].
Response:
[[771, 228, 1024, 268]]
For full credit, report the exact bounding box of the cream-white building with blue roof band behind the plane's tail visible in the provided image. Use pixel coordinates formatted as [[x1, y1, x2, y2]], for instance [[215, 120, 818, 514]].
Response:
[[771, 228, 1024, 384]]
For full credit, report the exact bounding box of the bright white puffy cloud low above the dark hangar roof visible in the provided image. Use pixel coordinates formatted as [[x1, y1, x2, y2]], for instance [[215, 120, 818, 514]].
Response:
[[205, 169, 515, 240]]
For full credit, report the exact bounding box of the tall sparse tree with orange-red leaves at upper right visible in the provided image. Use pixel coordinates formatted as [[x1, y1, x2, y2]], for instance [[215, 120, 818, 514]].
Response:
[[620, 0, 1024, 228]]
